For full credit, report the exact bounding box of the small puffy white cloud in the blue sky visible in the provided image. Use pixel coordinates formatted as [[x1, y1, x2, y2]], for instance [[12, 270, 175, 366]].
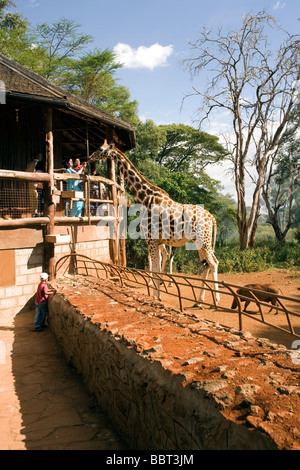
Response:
[[114, 42, 173, 70]]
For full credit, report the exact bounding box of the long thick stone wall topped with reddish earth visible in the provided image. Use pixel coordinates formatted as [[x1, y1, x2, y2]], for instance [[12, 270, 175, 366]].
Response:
[[49, 277, 300, 450]]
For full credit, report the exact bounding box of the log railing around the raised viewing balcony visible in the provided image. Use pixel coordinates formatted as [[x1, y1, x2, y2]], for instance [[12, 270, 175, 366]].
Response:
[[0, 170, 121, 227]]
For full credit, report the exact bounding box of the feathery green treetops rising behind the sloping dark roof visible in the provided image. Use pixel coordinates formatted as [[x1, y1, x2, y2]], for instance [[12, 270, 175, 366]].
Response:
[[0, 11, 139, 125]]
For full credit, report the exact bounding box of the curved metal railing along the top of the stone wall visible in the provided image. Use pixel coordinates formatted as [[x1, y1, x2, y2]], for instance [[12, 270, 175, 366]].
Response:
[[55, 253, 300, 338]]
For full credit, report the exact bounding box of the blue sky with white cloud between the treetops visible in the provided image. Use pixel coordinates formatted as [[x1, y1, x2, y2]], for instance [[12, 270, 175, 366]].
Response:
[[15, 0, 300, 198]]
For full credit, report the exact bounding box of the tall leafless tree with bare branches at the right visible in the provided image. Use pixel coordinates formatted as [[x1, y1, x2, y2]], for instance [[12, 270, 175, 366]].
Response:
[[185, 11, 300, 249]]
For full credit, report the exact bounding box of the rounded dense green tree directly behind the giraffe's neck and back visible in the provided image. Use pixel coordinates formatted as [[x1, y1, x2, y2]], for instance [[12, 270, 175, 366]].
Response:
[[129, 120, 226, 205]]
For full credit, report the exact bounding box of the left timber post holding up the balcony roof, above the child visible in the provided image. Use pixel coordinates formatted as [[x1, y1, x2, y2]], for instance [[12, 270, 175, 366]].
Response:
[[44, 108, 55, 281]]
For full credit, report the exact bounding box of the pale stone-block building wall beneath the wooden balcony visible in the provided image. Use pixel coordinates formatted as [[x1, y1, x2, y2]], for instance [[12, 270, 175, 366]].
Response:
[[0, 227, 110, 326]]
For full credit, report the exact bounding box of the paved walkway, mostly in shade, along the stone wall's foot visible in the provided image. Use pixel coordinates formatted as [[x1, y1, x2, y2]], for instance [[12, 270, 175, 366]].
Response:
[[0, 311, 126, 450]]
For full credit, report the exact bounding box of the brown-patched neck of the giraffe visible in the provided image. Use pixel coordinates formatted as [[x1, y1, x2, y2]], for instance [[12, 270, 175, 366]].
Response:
[[111, 151, 169, 208]]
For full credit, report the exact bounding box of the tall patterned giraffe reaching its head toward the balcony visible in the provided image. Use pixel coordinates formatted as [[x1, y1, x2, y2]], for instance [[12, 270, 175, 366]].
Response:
[[87, 141, 220, 308]]
